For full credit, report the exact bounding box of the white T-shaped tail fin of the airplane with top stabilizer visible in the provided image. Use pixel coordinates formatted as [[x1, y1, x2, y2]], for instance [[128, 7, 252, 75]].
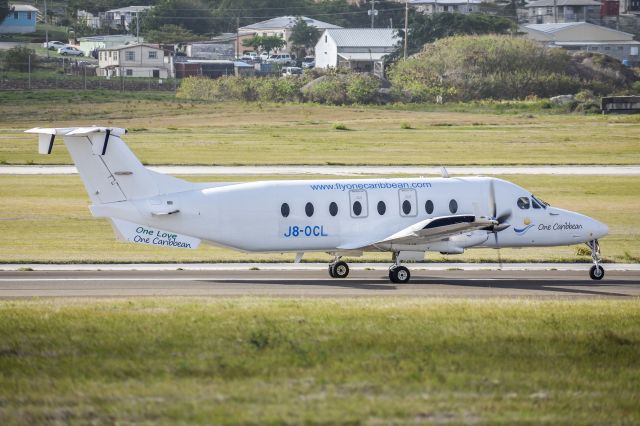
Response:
[[25, 127, 194, 204]]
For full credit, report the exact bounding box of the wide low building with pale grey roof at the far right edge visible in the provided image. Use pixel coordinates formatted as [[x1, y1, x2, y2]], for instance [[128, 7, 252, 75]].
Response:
[[520, 22, 640, 65]]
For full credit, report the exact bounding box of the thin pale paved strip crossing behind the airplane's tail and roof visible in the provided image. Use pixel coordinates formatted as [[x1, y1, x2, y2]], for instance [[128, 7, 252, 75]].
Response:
[[0, 165, 640, 176]]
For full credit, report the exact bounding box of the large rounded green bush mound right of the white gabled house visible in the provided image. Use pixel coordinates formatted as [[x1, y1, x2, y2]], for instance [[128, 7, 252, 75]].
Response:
[[389, 35, 629, 102]]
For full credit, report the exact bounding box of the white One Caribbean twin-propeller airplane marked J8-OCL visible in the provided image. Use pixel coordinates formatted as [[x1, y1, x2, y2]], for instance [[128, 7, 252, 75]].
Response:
[[26, 127, 608, 283]]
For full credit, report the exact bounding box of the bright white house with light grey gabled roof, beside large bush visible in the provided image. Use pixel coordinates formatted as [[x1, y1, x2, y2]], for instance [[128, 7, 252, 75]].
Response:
[[315, 28, 401, 75]]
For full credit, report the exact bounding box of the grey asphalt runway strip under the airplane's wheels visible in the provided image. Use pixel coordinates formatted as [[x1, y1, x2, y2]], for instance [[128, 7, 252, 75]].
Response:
[[0, 266, 640, 299]]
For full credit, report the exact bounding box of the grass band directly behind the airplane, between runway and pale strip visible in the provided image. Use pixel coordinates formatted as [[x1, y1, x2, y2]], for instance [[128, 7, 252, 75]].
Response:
[[0, 175, 640, 263]]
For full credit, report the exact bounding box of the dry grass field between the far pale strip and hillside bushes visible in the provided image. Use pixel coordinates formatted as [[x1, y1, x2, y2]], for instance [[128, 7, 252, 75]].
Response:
[[0, 91, 640, 165]]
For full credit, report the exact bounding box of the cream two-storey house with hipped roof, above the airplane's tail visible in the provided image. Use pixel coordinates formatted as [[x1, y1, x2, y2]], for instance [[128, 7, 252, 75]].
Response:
[[98, 44, 174, 78]]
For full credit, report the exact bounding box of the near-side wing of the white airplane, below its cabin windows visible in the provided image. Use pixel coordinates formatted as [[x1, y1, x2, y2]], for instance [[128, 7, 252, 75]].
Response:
[[338, 215, 498, 250]]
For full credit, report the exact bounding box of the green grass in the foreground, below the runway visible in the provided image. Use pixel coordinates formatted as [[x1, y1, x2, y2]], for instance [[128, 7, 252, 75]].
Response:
[[0, 298, 640, 425]]
